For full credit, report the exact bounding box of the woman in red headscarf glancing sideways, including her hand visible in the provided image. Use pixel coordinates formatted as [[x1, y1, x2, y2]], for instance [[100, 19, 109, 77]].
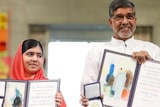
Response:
[[10, 39, 66, 107]]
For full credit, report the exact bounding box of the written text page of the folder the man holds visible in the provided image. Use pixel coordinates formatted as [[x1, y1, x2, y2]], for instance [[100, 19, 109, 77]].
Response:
[[130, 60, 160, 107]]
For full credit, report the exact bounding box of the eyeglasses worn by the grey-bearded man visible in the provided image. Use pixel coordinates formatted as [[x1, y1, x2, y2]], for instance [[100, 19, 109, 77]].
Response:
[[113, 14, 135, 22]]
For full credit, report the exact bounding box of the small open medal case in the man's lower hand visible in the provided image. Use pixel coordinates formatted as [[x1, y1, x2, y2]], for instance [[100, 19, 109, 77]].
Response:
[[84, 82, 103, 107]]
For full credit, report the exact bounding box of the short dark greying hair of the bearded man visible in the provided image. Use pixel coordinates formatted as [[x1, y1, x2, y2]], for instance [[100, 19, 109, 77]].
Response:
[[109, 0, 136, 18]]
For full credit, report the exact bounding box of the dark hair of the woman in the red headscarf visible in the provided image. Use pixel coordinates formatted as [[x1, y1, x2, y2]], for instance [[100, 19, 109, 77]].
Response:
[[22, 39, 43, 54]]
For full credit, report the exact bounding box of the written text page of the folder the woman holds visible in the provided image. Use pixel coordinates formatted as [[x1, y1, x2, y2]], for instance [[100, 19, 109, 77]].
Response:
[[26, 80, 60, 107]]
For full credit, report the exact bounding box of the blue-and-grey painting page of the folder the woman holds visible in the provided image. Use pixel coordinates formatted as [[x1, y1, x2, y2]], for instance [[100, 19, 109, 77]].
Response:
[[3, 81, 27, 107]]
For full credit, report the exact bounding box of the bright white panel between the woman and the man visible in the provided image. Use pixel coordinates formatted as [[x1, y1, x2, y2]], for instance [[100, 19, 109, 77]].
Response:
[[48, 42, 104, 107]]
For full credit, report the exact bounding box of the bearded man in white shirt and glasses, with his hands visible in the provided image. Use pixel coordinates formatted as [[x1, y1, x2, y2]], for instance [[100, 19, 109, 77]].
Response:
[[81, 0, 160, 107]]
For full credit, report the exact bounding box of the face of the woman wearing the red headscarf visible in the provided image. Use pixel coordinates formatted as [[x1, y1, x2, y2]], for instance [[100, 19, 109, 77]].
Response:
[[23, 46, 44, 76]]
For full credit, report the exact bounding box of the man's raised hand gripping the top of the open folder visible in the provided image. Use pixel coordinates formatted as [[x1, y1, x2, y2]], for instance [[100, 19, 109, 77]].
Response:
[[132, 51, 152, 64]]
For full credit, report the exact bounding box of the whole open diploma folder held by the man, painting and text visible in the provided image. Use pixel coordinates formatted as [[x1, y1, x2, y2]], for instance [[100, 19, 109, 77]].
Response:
[[98, 49, 160, 107]]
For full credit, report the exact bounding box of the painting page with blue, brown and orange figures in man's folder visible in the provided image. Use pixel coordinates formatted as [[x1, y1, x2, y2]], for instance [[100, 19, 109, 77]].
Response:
[[97, 49, 138, 107]]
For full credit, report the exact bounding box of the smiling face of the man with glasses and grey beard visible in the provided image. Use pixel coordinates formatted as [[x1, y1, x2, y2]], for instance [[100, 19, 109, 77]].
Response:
[[109, 7, 136, 40]]
